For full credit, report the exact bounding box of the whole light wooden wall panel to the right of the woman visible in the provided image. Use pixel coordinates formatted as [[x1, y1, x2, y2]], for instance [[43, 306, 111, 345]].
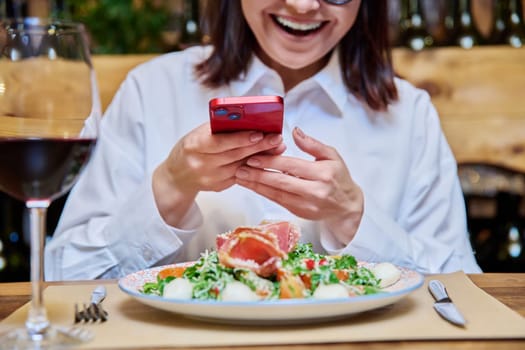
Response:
[[394, 46, 525, 171]]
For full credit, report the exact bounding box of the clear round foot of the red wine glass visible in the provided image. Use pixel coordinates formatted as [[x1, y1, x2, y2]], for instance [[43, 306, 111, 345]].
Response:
[[0, 326, 93, 350]]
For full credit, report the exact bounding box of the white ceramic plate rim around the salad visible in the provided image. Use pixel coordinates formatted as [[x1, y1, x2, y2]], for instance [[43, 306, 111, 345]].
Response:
[[118, 264, 424, 325]]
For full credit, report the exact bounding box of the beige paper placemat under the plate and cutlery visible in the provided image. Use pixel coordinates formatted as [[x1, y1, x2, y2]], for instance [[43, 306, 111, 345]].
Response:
[[0, 272, 525, 349]]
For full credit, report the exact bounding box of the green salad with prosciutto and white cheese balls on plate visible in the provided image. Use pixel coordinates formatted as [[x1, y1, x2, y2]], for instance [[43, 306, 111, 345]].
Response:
[[140, 221, 401, 302]]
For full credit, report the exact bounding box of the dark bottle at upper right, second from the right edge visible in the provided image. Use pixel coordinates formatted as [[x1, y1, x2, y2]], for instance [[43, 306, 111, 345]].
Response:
[[453, 0, 483, 49]]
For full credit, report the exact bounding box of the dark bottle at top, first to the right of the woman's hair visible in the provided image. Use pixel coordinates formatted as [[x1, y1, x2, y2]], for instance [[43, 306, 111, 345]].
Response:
[[399, 0, 434, 51]]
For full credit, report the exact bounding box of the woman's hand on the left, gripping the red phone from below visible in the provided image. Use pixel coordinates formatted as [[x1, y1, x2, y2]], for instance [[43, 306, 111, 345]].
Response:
[[153, 123, 285, 226]]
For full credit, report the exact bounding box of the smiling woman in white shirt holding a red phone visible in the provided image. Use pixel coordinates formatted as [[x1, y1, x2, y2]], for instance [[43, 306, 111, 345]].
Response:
[[46, 0, 480, 279]]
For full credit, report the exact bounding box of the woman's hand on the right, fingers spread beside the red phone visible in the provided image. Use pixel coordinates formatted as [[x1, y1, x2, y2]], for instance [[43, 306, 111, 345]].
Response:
[[236, 128, 364, 245]]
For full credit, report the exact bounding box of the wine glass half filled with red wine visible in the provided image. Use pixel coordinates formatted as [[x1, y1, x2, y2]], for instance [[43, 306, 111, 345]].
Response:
[[0, 18, 101, 349]]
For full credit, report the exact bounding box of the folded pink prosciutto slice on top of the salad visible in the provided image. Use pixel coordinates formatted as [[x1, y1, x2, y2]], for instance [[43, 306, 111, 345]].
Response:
[[216, 221, 300, 277]]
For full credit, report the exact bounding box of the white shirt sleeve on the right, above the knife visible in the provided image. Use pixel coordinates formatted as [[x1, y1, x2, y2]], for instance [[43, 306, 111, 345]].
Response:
[[321, 89, 481, 273]]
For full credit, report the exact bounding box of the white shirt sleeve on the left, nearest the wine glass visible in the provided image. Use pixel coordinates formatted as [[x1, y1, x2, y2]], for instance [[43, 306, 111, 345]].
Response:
[[45, 72, 202, 280]]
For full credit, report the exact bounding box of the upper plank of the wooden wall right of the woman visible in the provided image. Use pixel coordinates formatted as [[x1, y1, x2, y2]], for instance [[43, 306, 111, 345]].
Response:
[[394, 46, 525, 118]]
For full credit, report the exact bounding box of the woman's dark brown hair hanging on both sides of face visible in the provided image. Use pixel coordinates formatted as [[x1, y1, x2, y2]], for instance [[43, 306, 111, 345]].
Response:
[[196, 0, 397, 110]]
